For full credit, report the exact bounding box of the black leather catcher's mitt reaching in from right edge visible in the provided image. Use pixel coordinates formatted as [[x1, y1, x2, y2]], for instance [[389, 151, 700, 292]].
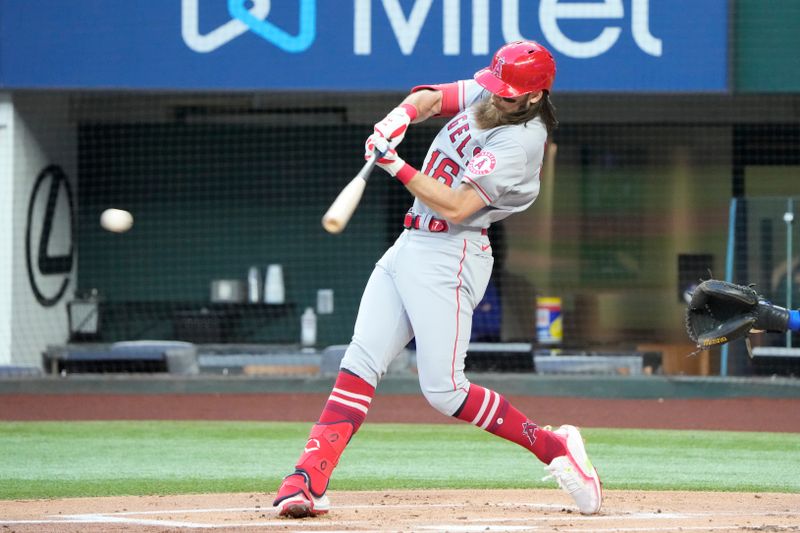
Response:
[[686, 279, 789, 350]]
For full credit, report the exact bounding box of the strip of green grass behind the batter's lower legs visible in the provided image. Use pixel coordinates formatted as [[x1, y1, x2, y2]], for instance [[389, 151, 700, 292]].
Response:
[[0, 422, 800, 499]]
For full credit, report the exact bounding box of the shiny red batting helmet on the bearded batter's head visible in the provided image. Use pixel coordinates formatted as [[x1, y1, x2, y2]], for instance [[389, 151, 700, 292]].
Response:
[[475, 41, 556, 98]]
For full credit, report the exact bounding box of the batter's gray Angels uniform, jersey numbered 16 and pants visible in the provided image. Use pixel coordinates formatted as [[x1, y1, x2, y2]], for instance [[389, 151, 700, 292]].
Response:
[[341, 80, 547, 415]]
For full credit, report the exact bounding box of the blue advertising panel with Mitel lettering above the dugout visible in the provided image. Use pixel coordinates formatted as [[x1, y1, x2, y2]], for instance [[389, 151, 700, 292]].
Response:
[[0, 0, 728, 92]]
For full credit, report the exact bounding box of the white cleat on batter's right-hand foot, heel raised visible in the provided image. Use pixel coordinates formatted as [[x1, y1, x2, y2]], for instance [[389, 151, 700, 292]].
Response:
[[542, 425, 603, 515]]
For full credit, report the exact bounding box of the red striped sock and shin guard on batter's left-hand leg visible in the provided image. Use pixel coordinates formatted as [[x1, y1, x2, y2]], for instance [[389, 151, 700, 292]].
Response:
[[295, 371, 375, 497]]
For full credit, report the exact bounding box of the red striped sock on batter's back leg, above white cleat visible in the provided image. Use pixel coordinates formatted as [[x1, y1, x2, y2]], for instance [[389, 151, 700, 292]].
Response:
[[453, 383, 567, 464]]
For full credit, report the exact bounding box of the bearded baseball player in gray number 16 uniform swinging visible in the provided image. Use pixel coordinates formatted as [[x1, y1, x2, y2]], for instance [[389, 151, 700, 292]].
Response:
[[273, 41, 602, 518]]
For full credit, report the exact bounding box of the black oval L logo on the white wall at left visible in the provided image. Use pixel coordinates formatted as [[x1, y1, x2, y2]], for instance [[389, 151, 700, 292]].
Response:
[[25, 165, 74, 307]]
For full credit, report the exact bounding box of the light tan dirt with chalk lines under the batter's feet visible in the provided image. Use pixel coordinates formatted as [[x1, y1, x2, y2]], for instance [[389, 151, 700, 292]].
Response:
[[0, 490, 800, 533]]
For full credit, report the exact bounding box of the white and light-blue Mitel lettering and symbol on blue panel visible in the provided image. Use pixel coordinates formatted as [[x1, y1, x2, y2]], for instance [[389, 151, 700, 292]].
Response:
[[181, 0, 662, 59]]
